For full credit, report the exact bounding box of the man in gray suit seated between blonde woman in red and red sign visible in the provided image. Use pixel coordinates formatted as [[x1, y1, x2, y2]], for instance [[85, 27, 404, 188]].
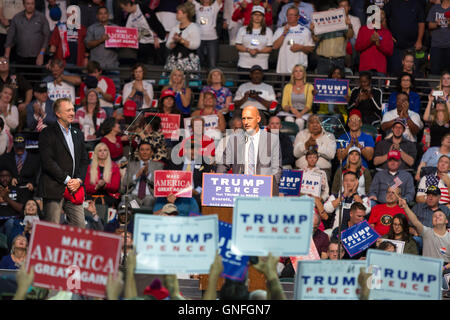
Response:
[[121, 141, 164, 207]]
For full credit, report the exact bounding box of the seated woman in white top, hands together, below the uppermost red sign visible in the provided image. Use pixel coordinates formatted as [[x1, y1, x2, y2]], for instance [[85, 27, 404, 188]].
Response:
[[122, 63, 153, 110]]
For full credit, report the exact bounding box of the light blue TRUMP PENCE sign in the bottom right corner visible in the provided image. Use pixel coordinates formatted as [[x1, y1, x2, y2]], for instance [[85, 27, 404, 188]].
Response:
[[366, 249, 444, 300]]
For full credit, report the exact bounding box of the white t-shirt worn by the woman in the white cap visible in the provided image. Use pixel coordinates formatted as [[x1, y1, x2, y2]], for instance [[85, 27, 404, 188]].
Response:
[[236, 26, 273, 70]]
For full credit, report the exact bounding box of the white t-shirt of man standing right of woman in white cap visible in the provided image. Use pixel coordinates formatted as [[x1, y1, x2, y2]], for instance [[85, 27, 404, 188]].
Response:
[[273, 24, 314, 73]]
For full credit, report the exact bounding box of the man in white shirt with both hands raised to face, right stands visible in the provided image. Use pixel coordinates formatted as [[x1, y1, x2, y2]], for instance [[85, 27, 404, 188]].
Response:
[[381, 92, 423, 142]]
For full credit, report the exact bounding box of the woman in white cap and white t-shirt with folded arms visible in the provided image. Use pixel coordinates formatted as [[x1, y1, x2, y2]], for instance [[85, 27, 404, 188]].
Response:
[[236, 6, 273, 70]]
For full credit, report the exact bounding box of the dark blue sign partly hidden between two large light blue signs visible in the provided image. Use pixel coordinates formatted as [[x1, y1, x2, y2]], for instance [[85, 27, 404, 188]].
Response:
[[219, 221, 249, 281]]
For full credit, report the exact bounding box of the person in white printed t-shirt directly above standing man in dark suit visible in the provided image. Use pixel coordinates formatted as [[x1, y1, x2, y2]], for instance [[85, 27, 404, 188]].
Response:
[[44, 58, 81, 104]]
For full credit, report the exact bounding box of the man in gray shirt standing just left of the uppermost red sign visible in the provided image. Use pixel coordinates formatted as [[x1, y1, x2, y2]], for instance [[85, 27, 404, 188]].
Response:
[[84, 7, 119, 69]]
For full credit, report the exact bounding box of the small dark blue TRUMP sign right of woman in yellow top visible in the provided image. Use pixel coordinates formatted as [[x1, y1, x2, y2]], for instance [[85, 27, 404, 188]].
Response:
[[314, 79, 348, 104]]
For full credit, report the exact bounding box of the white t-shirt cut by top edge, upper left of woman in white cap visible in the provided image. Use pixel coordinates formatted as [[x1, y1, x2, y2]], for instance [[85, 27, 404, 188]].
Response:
[[193, 1, 220, 40]]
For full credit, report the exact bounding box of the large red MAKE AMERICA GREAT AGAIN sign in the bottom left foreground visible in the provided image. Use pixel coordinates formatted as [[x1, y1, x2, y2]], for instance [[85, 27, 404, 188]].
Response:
[[26, 221, 122, 298]]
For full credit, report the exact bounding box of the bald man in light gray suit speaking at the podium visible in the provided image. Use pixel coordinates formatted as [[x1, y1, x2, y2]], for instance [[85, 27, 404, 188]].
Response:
[[217, 106, 282, 195]]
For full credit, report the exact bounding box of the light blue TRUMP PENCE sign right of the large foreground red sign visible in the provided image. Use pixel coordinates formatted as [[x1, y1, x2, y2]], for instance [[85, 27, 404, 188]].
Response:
[[133, 214, 219, 274]]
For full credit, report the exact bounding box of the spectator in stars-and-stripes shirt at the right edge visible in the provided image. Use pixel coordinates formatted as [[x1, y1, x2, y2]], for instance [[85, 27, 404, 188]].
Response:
[[416, 155, 450, 206]]
